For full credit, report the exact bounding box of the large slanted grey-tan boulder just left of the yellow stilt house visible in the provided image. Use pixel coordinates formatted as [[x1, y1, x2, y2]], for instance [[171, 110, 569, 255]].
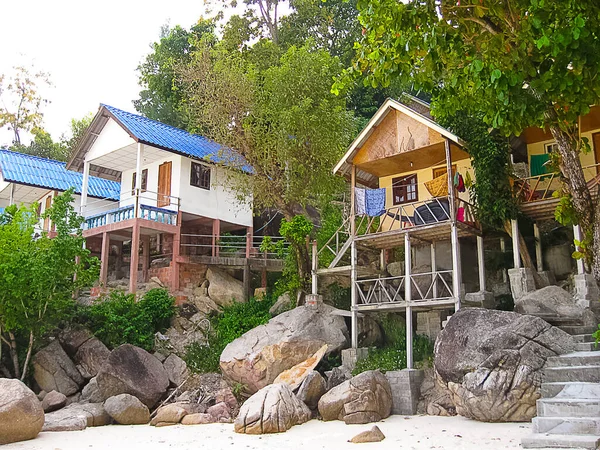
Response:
[[220, 305, 348, 394]]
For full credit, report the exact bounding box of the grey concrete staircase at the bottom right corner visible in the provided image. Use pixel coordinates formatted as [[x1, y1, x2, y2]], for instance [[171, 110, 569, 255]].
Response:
[[521, 326, 600, 450]]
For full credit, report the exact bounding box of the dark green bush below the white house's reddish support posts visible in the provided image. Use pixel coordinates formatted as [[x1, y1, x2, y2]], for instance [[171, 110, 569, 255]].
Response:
[[82, 289, 175, 351]]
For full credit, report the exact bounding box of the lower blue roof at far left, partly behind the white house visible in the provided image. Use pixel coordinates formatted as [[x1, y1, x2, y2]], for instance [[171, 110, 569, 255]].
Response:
[[0, 150, 121, 200]]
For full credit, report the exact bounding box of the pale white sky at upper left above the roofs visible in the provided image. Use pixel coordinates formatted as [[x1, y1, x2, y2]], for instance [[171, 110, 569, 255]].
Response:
[[0, 0, 224, 145]]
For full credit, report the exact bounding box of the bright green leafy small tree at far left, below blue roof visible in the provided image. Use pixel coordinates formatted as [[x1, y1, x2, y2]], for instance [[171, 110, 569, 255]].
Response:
[[0, 190, 99, 380]]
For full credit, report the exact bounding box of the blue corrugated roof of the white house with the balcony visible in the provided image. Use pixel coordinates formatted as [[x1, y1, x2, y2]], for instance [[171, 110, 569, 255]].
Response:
[[101, 104, 252, 172]]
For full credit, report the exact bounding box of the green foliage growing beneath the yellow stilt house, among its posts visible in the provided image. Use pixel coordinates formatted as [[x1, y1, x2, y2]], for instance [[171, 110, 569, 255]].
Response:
[[352, 314, 433, 375]]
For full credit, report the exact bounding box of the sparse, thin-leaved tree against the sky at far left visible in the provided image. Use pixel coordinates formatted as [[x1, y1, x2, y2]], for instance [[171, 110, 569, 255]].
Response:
[[0, 66, 50, 144]]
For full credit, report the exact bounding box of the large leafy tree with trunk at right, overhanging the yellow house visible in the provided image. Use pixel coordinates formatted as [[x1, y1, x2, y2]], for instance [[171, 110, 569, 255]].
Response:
[[334, 0, 600, 280]]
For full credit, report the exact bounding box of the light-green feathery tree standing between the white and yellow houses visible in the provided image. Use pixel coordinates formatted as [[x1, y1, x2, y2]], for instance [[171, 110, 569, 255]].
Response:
[[180, 41, 355, 280]]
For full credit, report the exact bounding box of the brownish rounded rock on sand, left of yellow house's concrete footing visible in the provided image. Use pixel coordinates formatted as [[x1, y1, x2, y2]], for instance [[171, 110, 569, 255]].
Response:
[[318, 370, 392, 424]]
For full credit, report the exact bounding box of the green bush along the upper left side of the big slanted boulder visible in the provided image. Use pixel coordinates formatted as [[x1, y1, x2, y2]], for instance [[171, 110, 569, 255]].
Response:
[[184, 297, 274, 373]]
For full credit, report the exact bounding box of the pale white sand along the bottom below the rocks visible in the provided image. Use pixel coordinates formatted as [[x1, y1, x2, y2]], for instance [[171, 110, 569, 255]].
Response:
[[2, 416, 531, 450]]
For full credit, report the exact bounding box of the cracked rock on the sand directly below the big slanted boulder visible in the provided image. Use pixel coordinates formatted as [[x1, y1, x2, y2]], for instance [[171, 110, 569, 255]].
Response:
[[234, 384, 311, 434]]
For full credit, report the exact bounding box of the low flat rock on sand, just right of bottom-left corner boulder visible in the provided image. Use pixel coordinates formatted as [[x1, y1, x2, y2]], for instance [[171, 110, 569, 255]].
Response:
[[42, 403, 112, 431]]
